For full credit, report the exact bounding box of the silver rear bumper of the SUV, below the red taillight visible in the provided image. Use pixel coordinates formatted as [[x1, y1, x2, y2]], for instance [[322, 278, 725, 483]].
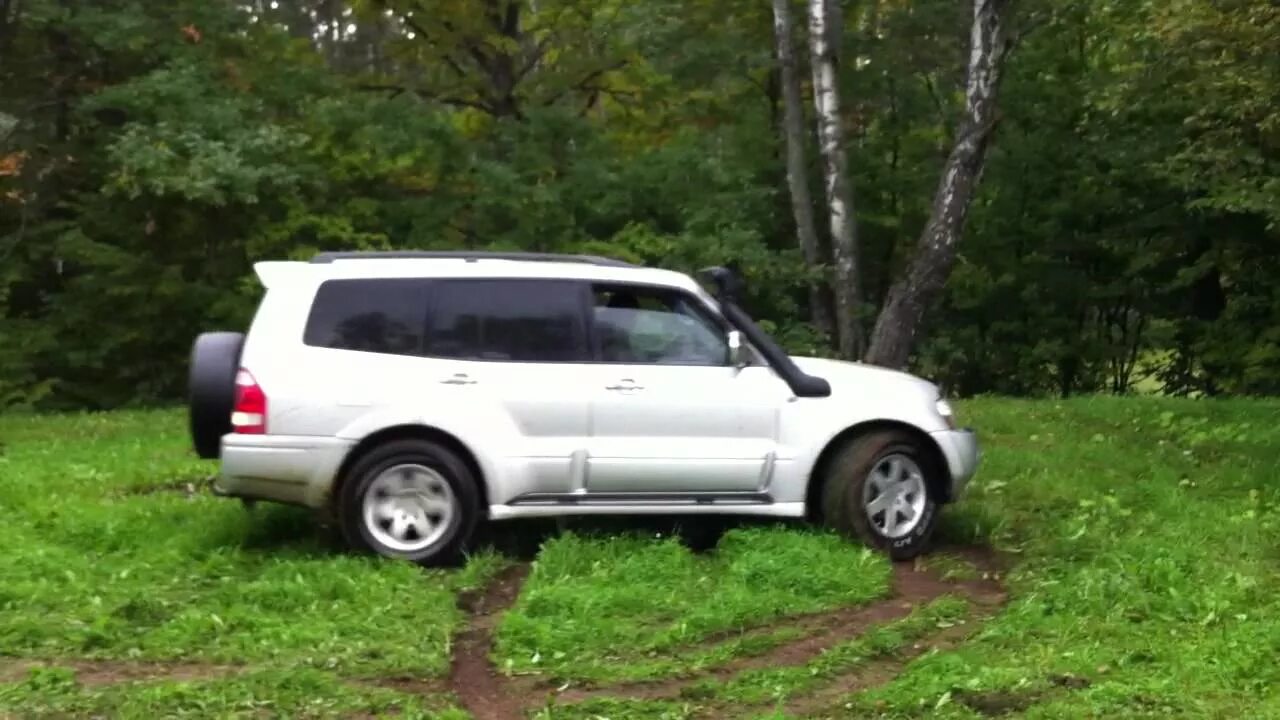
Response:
[[214, 434, 355, 507]]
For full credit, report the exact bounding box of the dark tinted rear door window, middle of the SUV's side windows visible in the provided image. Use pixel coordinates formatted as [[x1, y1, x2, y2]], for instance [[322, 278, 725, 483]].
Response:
[[426, 279, 589, 363]]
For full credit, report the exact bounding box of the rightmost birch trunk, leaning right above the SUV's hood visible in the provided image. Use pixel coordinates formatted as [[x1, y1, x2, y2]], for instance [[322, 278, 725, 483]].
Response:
[[867, 0, 1011, 368]]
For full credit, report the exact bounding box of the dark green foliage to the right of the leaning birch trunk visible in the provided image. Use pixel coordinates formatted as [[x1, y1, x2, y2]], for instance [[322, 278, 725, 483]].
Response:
[[920, 0, 1280, 395]]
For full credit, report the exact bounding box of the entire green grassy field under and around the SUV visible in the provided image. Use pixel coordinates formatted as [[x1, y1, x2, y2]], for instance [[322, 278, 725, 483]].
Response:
[[0, 398, 1280, 720]]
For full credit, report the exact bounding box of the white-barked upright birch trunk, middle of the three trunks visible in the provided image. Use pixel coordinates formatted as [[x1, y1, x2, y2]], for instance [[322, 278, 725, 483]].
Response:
[[809, 0, 863, 359]]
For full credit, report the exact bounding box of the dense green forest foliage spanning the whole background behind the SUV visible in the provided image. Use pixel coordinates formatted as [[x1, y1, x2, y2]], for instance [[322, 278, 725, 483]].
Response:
[[0, 0, 1280, 409]]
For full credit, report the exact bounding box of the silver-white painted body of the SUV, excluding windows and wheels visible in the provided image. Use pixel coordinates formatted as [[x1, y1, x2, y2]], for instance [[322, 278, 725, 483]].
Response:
[[215, 258, 978, 520]]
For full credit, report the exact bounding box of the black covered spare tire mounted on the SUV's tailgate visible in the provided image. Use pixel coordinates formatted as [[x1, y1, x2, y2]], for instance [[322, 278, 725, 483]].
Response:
[[187, 332, 244, 460]]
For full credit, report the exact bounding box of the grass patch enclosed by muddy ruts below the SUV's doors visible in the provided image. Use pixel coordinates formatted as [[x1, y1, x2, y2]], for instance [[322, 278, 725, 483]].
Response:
[[498, 527, 890, 682]]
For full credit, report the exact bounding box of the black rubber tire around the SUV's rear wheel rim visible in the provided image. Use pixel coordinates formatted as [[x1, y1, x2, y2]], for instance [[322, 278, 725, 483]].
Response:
[[337, 439, 481, 566]]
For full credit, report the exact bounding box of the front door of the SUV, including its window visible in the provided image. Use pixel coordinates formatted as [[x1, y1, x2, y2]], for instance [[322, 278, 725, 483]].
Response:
[[584, 284, 787, 495]]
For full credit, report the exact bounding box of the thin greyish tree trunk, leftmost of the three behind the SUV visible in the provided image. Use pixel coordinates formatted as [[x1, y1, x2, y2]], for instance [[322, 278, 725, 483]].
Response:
[[773, 0, 835, 337]]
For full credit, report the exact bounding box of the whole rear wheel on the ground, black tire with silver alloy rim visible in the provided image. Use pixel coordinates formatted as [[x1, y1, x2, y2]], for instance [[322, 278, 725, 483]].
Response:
[[337, 439, 481, 566]]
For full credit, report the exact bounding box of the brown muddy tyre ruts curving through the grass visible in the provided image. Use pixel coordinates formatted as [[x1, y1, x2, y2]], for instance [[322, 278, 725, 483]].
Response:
[[0, 548, 1016, 720]]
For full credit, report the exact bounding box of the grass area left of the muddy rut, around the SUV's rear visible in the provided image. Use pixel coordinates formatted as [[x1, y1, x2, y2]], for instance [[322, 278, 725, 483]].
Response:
[[0, 413, 498, 675]]
